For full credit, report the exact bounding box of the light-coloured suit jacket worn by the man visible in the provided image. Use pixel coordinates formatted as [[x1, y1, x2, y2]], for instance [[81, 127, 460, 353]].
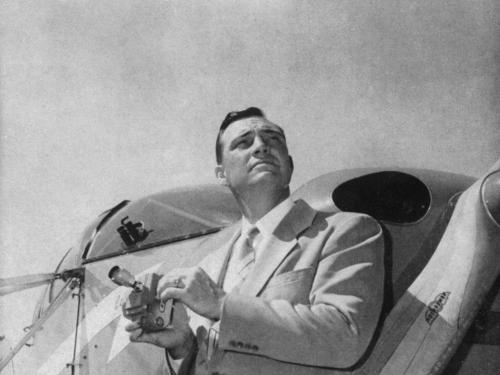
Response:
[[179, 201, 384, 375]]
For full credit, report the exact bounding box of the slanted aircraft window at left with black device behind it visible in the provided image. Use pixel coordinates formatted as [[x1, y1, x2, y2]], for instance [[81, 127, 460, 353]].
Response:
[[81, 185, 241, 263]]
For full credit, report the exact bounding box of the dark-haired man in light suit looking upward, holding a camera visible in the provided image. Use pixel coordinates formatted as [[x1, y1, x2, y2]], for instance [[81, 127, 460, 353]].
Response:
[[127, 107, 384, 374]]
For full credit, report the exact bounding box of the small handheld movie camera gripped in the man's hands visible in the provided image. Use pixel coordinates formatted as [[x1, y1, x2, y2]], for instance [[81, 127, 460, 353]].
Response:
[[108, 266, 173, 332]]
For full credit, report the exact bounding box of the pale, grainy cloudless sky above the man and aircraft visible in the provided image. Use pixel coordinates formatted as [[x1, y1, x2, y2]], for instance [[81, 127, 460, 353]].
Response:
[[0, 0, 500, 346]]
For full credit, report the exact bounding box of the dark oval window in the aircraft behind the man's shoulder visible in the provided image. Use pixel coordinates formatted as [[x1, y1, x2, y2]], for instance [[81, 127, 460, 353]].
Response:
[[332, 171, 431, 224]]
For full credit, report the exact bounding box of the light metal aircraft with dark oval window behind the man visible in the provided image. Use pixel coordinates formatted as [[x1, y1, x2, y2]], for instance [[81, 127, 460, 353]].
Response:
[[0, 161, 500, 375]]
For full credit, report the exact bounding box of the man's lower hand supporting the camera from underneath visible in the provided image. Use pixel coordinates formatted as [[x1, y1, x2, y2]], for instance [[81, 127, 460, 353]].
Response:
[[125, 303, 195, 359]]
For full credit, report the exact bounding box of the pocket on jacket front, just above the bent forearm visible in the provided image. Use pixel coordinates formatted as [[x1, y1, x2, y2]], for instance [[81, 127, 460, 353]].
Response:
[[261, 267, 314, 305]]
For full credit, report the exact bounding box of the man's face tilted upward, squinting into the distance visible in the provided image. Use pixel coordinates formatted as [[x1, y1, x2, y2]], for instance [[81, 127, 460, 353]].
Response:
[[216, 117, 293, 191]]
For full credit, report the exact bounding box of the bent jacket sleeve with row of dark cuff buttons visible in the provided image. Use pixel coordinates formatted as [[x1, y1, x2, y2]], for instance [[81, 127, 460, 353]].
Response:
[[219, 214, 384, 368]]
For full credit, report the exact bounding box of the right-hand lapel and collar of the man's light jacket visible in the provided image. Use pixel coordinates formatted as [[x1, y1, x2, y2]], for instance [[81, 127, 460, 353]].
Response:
[[239, 200, 316, 296]]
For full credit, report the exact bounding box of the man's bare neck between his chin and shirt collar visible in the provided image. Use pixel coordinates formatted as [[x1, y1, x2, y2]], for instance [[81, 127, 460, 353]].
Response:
[[235, 188, 290, 224]]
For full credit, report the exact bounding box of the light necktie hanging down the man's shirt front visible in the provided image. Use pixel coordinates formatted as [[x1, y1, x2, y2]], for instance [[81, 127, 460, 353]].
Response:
[[224, 227, 259, 292]]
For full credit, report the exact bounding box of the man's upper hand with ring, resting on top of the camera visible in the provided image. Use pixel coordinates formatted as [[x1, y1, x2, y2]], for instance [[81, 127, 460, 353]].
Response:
[[157, 267, 226, 320]]
